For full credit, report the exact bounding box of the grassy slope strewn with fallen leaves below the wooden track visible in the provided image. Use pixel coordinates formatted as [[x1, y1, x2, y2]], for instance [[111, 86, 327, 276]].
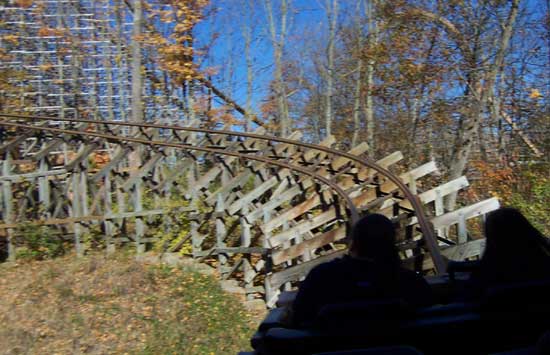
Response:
[[0, 256, 254, 354]]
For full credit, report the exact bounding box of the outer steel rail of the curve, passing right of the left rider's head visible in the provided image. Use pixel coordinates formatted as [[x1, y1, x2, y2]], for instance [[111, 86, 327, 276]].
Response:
[[0, 113, 446, 273]]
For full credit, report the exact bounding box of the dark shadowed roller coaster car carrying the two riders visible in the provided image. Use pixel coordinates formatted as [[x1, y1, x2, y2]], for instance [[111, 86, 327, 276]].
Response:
[[251, 272, 550, 355]]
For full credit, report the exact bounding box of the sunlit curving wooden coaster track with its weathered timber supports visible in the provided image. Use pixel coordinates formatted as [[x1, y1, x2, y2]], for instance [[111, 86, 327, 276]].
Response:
[[0, 114, 498, 306]]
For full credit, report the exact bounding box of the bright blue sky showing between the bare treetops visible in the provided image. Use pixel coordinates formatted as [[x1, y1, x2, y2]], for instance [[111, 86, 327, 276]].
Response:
[[189, 0, 548, 117]]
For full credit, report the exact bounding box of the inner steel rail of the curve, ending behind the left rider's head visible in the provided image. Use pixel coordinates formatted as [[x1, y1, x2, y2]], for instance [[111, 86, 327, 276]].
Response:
[[0, 121, 359, 223]]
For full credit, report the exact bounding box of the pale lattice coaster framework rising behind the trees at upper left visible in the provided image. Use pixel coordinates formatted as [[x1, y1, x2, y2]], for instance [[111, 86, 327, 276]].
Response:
[[0, 0, 204, 122]]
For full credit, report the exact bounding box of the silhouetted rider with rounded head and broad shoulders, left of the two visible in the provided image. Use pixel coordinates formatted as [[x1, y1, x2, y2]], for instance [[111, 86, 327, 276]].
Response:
[[291, 214, 433, 327]]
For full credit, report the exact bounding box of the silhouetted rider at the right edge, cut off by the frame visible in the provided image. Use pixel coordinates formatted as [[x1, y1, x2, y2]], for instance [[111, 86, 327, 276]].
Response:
[[467, 207, 550, 298]]
